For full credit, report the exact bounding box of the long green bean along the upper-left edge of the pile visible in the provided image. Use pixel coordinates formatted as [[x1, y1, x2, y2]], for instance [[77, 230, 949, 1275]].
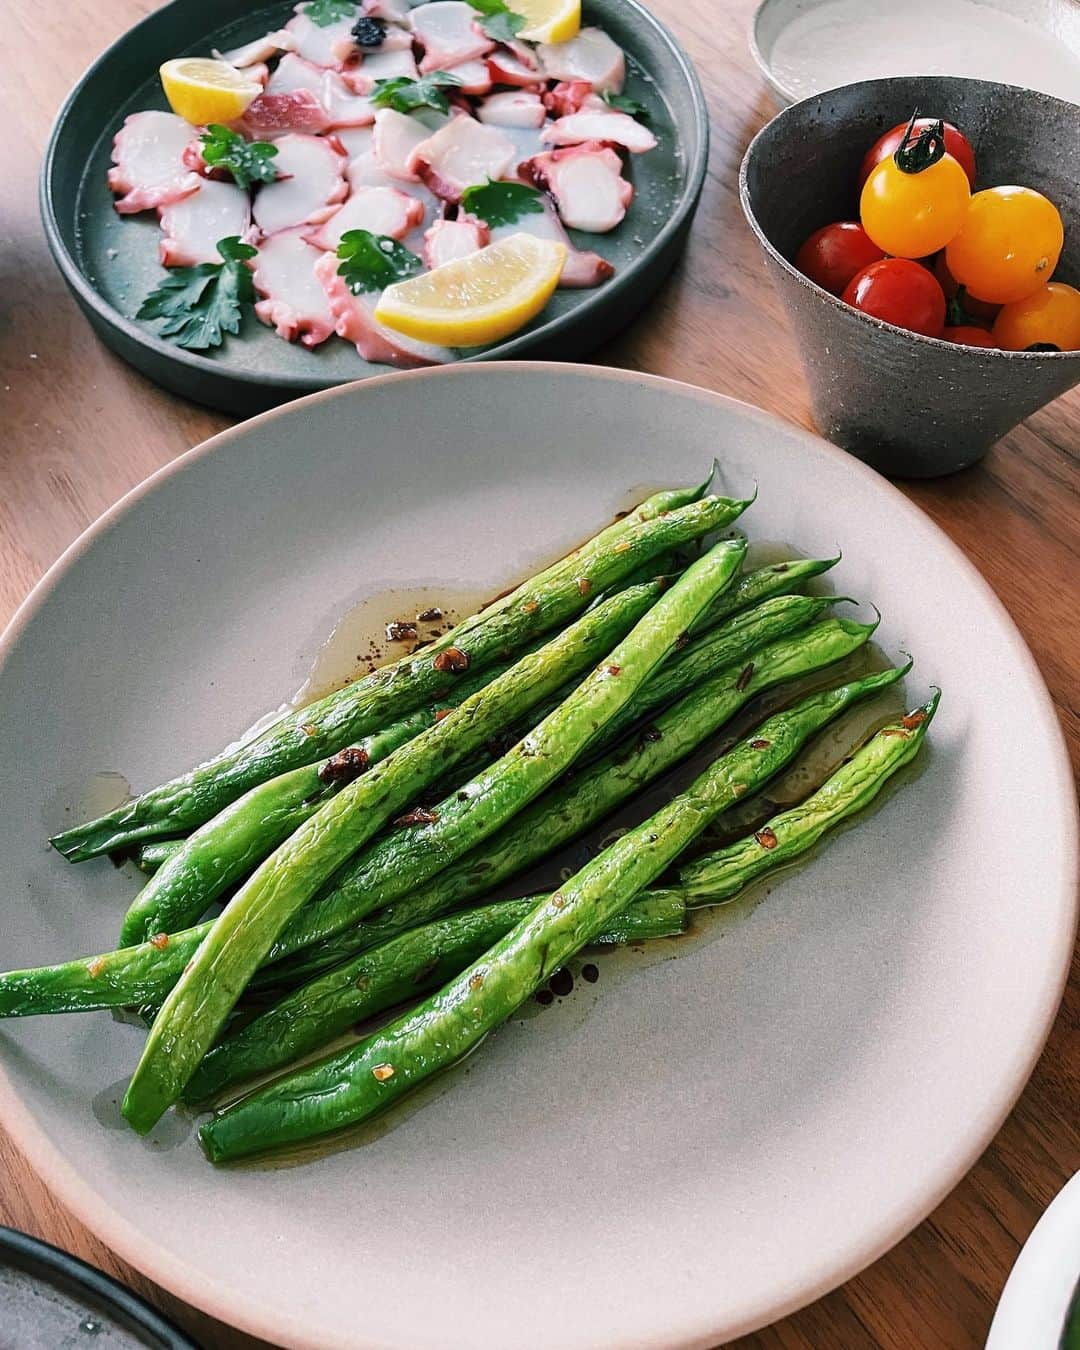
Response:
[[51, 491, 747, 861]]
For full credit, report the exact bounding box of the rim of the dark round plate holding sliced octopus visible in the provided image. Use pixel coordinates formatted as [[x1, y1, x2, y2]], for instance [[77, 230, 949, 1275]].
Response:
[[38, 0, 709, 396]]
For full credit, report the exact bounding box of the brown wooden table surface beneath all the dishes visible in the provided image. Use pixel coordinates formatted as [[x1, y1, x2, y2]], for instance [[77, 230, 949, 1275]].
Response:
[[0, 0, 1080, 1350]]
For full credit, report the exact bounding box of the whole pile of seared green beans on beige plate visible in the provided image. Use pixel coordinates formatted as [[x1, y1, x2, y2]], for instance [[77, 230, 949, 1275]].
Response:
[[0, 482, 940, 1162]]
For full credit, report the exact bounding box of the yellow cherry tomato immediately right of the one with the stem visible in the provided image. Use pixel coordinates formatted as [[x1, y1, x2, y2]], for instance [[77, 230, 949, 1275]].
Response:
[[945, 188, 1065, 305]]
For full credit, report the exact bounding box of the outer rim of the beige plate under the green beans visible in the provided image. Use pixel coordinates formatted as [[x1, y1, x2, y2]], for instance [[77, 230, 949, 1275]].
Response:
[[0, 360, 1080, 1350]]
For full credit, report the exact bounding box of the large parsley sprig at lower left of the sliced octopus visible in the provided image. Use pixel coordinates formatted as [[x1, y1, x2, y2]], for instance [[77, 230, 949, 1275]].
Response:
[[135, 235, 258, 351]]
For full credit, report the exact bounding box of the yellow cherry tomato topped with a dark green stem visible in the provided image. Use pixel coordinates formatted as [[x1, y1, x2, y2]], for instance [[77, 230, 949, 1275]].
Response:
[[859, 155, 971, 258]]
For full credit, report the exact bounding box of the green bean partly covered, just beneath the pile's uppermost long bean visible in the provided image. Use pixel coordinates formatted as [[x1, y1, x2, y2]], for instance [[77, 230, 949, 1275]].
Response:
[[119, 662, 523, 946]]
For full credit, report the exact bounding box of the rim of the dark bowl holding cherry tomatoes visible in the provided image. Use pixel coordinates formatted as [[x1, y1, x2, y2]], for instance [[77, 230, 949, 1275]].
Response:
[[738, 76, 1080, 362]]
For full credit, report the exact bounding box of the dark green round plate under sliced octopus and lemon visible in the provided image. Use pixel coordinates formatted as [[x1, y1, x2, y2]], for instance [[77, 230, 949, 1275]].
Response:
[[41, 0, 709, 414]]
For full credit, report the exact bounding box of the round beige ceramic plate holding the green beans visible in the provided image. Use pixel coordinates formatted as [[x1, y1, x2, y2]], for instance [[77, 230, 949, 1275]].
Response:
[[0, 363, 1076, 1350]]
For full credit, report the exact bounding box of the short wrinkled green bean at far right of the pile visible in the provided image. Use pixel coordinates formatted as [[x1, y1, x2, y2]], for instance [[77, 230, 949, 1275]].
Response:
[[675, 691, 941, 906]]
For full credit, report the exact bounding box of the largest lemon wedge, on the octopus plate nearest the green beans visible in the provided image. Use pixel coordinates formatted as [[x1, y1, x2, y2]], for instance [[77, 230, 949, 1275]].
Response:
[[375, 235, 566, 347]]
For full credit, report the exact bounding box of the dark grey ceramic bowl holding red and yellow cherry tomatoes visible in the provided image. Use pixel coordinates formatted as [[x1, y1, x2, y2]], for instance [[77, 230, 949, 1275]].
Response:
[[740, 76, 1080, 478]]
